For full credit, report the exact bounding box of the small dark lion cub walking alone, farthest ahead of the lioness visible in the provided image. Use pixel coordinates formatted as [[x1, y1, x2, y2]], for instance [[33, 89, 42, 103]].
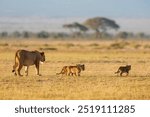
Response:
[[115, 65, 131, 76]]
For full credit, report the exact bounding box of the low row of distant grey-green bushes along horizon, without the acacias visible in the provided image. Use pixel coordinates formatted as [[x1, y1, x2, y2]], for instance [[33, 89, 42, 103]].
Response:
[[0, 31, 150, 39]]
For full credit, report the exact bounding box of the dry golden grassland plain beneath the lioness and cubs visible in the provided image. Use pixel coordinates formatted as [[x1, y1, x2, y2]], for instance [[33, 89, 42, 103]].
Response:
[[0, 39, 150, 100]]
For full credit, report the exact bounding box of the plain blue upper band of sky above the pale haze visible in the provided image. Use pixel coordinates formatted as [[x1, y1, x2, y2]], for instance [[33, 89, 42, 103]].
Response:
[[0, 0, 150, 18]]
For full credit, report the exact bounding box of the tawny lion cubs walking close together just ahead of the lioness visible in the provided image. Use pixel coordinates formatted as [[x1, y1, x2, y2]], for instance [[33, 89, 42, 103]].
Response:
[[56, 64, 85, 76]]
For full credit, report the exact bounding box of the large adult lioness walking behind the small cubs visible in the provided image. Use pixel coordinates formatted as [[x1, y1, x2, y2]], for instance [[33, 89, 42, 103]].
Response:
[[12, 50, 45, 76]]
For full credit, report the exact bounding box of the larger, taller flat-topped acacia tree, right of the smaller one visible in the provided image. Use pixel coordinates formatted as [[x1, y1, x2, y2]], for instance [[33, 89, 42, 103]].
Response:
[[84, 17, 119, 37]]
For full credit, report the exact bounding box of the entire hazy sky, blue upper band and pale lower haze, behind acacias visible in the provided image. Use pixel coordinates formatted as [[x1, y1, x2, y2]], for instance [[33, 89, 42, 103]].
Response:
[[0, 0, 150, 34]]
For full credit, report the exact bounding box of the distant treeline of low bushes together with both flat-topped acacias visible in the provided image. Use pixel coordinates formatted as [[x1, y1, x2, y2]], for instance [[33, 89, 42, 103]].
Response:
[[0, 17, 150, 39]]
